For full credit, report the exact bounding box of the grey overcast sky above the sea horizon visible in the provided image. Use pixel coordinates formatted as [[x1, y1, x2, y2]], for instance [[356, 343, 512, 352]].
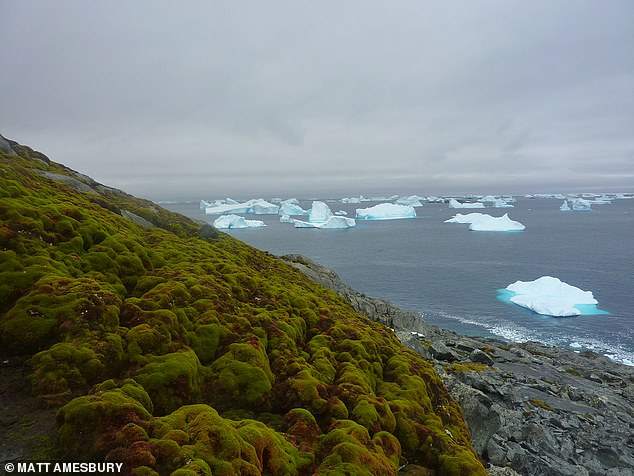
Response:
[[0, 0, 634, 200]]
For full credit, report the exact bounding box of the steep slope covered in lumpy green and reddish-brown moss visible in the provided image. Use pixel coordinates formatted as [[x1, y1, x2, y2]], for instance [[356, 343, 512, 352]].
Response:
[[0, 139, 486, 475]]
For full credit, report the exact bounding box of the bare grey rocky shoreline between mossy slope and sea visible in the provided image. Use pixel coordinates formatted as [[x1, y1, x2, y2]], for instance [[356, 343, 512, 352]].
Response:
[[283, 255, 634, 476]]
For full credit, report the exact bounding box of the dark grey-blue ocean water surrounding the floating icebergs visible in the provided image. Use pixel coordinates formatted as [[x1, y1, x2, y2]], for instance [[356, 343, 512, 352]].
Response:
[[164, 198, 634, 365]]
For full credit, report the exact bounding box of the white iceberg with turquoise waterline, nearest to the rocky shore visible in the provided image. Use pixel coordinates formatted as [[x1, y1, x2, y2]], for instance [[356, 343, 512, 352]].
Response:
[[501, 276, 604, 317]]
